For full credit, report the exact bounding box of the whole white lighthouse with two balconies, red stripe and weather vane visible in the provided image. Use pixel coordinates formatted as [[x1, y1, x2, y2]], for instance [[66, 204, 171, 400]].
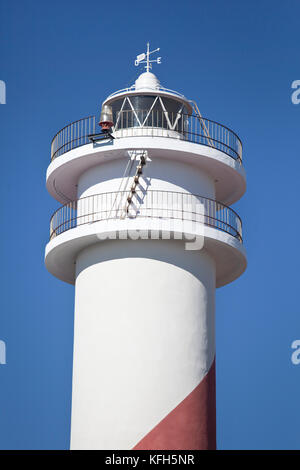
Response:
[[46, 45, 246, 450]]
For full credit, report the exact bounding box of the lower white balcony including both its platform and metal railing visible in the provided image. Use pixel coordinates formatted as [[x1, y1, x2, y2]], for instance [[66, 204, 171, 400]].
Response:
[[46, 190, 246, 286]]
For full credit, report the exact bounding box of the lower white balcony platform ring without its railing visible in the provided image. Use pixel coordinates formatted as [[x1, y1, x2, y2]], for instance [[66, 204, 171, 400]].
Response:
[[45, 218, 247, 287]]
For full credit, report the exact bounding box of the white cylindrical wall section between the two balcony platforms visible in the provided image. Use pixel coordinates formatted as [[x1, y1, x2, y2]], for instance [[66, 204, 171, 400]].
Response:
[[78, 155, 215, 227]]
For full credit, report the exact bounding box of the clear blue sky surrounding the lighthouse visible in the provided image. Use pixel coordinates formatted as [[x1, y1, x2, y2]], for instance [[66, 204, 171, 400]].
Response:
[[0, 0, 300, 449]]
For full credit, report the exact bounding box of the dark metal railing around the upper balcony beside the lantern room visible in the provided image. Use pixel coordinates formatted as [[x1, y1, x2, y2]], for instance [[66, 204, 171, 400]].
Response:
[[51, 110, 242, 163]]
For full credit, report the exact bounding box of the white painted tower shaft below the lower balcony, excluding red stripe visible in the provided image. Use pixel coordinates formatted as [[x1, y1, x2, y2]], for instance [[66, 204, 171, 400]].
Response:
[[71, 240, 215, 449]]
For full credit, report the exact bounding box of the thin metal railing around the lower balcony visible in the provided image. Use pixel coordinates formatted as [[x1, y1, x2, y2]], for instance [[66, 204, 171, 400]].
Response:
[[50, 189, 242, 242]]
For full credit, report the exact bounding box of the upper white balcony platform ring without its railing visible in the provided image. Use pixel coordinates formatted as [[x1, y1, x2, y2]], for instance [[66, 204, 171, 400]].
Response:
[[47, 135, 246, 205]]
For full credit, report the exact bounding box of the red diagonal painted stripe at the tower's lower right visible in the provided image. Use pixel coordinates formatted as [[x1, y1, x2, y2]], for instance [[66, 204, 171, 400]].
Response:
[[134, 361, 216, 450]]
